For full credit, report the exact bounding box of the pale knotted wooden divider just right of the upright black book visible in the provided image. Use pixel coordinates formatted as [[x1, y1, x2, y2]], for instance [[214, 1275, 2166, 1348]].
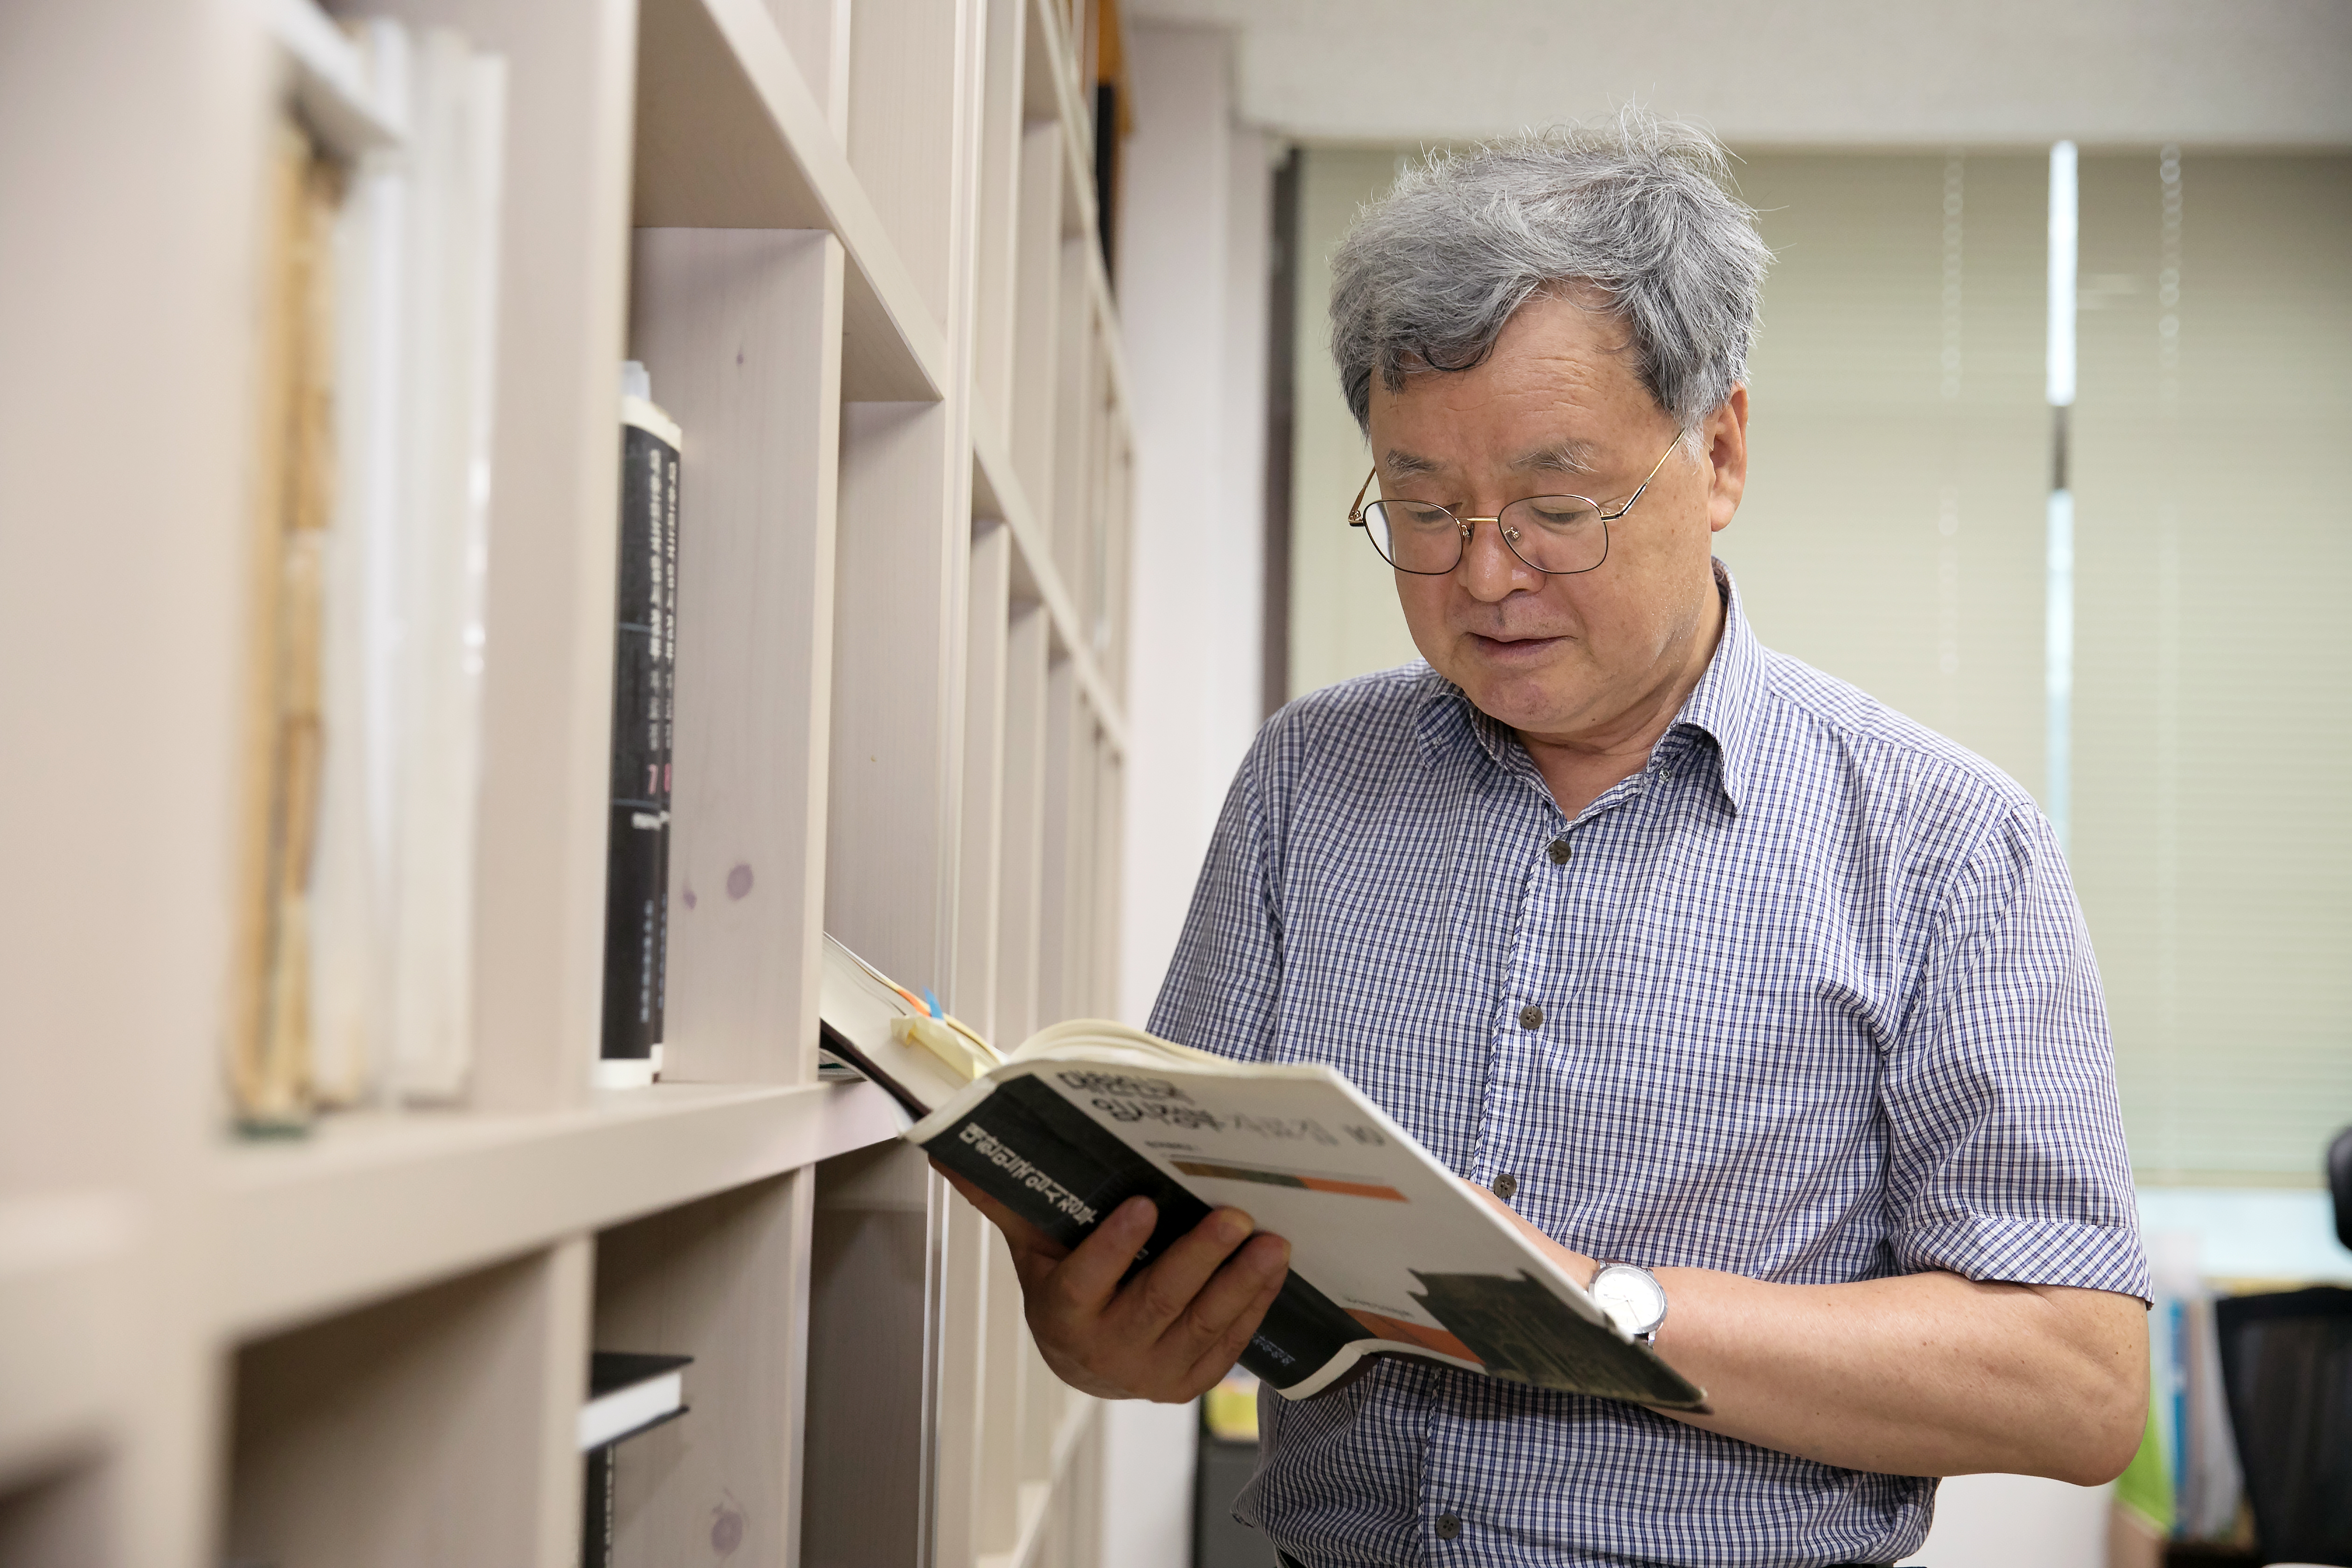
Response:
[[630, 228, 844, 1084]]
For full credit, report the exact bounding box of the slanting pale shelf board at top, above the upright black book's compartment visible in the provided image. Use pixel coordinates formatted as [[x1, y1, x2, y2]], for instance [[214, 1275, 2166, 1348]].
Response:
[[633, 0, 948, 402]]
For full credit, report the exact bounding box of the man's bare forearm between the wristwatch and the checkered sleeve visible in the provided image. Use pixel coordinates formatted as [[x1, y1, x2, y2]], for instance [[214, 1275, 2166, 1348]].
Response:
[[1658, 1269, 2148, 1486]]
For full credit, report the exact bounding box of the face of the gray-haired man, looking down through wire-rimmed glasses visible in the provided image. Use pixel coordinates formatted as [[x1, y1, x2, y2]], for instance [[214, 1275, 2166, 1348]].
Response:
[[1371, 294, 1748, 743]]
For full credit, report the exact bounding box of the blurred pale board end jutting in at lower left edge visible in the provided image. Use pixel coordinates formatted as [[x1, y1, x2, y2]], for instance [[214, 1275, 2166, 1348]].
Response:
[[0, 1192, 139, 1486]]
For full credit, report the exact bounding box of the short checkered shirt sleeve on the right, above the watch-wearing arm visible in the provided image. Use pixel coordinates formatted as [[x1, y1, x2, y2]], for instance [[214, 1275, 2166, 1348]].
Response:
[[1882, 806, 2150, 1300]]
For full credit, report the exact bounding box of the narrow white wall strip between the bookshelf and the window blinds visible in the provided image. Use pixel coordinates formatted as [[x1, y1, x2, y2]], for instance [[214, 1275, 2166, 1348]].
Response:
[[1101, 26, 1270, 1568]]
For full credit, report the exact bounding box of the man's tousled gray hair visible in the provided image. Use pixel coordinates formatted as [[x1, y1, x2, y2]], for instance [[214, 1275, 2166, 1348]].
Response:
[[1331, 106, 1771, 435]]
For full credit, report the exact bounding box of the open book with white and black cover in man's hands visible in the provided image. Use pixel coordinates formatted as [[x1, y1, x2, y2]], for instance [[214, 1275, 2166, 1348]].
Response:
[[821, 938, 1705, 1410]]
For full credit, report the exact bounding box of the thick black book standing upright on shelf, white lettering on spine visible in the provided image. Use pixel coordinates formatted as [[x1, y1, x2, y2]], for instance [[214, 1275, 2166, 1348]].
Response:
[[597, 364, 682, 1088]]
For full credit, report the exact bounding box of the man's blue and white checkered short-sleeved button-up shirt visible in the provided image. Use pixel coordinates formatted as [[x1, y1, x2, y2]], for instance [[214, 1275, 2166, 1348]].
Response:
[[1153, 567, 2148, 1568]]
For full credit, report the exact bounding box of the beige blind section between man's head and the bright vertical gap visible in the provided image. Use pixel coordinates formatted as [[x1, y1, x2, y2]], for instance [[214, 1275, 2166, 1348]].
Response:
[[1717, 155, 2049, 788]]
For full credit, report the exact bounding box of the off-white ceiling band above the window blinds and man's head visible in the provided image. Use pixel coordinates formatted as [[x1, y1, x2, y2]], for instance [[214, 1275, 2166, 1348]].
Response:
[[1124, 0, 2352, 146]]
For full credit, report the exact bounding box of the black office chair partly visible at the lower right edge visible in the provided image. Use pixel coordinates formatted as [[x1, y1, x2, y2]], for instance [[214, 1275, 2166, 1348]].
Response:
[[2213, 1128, 2352, 1568]]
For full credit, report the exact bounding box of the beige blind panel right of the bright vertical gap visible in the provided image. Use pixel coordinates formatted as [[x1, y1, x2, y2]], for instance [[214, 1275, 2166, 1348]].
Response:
[[2074, 153, 2352, 1180]]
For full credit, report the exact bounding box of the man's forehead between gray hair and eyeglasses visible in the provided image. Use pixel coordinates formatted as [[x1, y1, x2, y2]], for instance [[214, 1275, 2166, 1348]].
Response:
[[1371, 294, 1656, 461]]
